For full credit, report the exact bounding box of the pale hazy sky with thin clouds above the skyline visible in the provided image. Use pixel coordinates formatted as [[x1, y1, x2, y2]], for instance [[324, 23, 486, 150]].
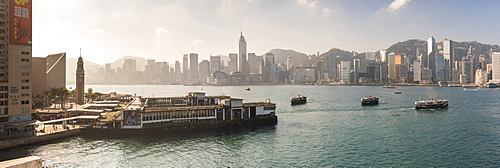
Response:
[[32, 0, 500, 64]]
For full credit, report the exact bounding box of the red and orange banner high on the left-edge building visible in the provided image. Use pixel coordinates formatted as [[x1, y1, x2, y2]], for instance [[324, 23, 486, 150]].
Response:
[[9, 0, 32, 44]]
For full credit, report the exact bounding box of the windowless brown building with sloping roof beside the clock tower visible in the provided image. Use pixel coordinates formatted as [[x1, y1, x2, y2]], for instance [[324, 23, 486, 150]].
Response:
[[32, 53, 66, 96]]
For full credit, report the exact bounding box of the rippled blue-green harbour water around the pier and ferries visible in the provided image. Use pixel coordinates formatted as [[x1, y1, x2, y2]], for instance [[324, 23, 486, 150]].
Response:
[[0, 85, 500, 167]]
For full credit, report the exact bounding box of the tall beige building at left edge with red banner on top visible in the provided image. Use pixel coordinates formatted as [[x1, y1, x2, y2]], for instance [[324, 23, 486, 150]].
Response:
[[0, 0, 32, 124]]
